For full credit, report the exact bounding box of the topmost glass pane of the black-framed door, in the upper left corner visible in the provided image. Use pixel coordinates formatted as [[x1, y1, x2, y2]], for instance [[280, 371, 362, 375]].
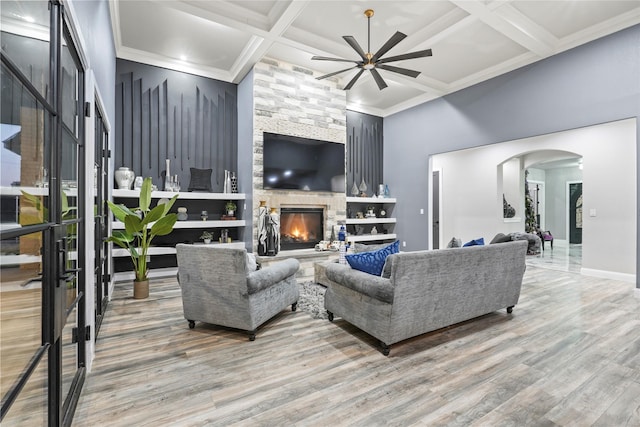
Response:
[[0, 0, 50, 100]]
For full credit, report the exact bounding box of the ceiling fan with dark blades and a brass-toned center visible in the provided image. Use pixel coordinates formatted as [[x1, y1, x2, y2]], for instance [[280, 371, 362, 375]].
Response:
[[311, 9, 431, 90]]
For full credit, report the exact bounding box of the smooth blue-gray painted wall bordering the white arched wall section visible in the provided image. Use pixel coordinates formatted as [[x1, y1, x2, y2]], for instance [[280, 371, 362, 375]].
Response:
[[384, 25, 640, 287]]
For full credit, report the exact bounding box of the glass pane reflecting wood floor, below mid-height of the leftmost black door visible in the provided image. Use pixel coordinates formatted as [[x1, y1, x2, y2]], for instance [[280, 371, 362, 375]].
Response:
[[0, 233, 42, 396]]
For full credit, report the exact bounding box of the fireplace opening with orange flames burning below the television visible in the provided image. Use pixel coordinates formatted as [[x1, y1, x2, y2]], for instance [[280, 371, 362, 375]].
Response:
[[280, 207, 324, 250]]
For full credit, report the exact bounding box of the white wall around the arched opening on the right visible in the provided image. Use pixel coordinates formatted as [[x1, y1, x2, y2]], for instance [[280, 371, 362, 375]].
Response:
[[432, 118, 637, 281]]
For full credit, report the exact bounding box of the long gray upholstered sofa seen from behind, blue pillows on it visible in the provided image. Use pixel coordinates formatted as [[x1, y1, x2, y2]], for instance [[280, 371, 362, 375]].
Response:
[[324, 241, 527, 355]]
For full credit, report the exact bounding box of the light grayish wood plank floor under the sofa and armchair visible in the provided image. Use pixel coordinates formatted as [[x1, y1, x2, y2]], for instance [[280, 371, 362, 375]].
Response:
[[74, 266, 640, 427]]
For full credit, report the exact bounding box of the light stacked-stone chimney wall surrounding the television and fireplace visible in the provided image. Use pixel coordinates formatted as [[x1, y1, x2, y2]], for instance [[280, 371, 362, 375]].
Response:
[[252, 59, 347, 248]]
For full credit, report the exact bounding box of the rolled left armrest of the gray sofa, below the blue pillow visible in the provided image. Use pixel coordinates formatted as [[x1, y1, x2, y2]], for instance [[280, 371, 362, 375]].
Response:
[[326, 264, 393, 304]]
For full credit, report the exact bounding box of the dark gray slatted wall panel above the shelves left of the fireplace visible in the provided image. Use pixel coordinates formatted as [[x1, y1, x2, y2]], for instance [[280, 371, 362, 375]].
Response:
[[115, 59, 238, 192]]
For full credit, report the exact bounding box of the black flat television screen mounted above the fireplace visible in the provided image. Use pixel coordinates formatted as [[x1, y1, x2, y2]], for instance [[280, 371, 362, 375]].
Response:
[[262, 132, 345, 193]]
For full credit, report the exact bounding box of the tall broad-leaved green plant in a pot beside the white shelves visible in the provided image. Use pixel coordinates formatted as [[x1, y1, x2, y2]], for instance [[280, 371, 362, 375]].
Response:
[[107, 178, 178, 299]]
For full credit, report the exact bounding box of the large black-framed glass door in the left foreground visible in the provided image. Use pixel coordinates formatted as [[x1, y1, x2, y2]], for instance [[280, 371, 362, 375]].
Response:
[[0, 0, 87, 426]]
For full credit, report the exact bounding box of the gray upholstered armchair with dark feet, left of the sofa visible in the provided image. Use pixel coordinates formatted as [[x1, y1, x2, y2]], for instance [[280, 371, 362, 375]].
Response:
[[176, 244, 300, 341]]
